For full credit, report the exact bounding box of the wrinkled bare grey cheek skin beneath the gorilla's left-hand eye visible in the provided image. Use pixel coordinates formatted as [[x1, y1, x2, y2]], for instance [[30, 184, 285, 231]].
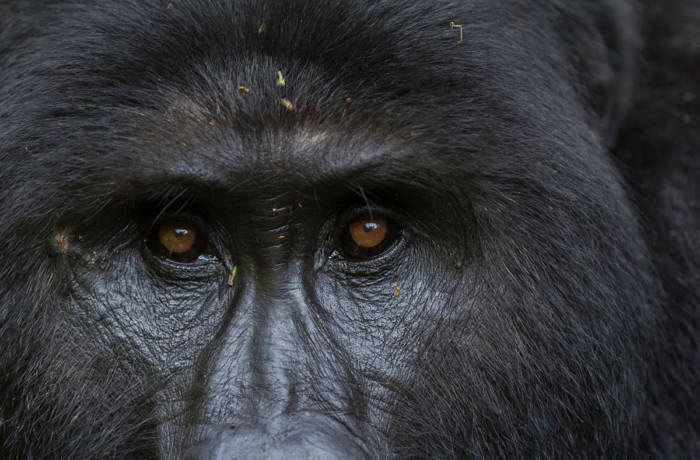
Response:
[[69, 251, 227, 370]]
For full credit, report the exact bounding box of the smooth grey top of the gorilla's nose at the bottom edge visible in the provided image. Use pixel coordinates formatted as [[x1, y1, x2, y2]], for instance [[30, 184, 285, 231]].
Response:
[[185, 416, 369, 460]]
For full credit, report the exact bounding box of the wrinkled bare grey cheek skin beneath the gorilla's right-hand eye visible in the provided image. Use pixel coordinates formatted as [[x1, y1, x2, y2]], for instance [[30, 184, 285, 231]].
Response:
[[315, 244, 460, 377]]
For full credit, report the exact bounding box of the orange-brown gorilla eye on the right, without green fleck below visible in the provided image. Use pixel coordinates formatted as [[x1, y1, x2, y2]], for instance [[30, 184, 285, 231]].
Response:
[[340, 216, 401, 261]]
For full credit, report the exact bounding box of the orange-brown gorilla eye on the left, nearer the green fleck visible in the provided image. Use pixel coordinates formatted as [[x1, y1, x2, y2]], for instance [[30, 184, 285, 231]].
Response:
[[148, 220, 211, 263]]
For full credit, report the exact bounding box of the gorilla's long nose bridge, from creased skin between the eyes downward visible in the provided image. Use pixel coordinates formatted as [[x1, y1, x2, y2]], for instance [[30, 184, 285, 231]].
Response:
[[205, 208, 306, 423]]
